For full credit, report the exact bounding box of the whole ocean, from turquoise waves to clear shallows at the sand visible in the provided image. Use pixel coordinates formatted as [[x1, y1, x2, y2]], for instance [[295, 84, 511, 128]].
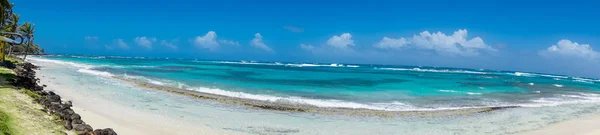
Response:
[[29, 55, 600, 134]]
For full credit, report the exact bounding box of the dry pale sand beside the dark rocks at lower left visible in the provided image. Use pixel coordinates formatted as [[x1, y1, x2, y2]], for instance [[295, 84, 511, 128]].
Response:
[[38, 69, 235, 135]]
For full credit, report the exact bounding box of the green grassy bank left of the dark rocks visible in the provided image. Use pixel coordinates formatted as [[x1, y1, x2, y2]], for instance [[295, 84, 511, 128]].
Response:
[[0, 58, 75, 135]]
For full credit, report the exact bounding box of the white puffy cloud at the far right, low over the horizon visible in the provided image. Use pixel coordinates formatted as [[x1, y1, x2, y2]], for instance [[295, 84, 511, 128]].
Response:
[[542, 39, 600, 59]]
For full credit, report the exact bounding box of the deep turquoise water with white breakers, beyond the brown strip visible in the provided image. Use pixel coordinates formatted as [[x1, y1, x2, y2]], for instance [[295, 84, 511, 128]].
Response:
[[33, 56, 600, 111]]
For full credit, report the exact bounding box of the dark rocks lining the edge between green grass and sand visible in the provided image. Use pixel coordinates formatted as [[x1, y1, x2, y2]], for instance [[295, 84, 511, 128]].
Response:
[[11, 62, 117, 135]]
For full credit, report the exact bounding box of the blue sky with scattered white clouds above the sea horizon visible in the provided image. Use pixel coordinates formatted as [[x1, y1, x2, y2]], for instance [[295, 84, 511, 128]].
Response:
[[11, 0, 600, 78]]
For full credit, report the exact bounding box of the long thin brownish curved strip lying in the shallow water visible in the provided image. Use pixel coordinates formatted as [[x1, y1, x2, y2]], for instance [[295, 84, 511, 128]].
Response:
[[112, 76, 520, 118]]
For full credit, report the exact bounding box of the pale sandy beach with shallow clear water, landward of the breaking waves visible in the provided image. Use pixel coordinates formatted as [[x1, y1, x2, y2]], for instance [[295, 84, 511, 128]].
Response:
[[32, 58, 600, 135]]
